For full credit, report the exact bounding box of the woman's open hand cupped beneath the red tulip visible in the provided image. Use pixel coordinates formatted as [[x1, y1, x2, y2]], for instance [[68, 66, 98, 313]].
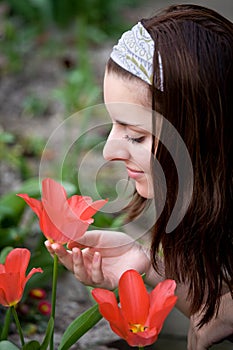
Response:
[[45, 230, 150, 289]]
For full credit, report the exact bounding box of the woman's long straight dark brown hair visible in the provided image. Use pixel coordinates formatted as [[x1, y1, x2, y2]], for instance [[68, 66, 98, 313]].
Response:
[[108, 5, 233, 326]]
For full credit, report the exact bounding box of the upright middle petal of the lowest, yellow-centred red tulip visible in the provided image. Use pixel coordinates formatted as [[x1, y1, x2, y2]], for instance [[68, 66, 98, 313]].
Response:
[[119, 270, 150, 325]]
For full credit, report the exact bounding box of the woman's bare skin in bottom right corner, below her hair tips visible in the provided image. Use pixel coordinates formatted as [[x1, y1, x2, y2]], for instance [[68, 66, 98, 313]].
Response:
[[188, 293, 233, 350]]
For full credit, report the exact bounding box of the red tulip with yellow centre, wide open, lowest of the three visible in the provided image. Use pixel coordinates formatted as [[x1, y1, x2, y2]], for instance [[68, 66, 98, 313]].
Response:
[[92, 270, 177, 346]]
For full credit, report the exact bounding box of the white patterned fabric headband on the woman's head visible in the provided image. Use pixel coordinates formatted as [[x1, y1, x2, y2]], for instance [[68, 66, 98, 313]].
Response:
[[110, 22, 163, 90]]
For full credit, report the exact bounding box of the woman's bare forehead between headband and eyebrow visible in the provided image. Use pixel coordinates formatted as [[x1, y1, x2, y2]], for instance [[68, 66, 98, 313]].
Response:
[[104, 73, 152, 131]]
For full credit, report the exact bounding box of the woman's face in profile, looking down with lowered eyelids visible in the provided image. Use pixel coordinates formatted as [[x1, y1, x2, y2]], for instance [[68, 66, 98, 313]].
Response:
[[103, 72, 154, 198]]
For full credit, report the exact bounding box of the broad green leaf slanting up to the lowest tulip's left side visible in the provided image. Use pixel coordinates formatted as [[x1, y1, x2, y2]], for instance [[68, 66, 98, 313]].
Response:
[[58, 304, 102, 350]]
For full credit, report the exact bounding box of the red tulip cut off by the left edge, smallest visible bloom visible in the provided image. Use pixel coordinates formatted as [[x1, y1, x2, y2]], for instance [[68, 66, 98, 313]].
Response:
[[0, 248, 43, 306]]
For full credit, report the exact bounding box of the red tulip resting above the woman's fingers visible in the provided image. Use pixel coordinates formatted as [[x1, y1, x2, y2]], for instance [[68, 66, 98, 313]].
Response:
[[18, 179, 107, 244]]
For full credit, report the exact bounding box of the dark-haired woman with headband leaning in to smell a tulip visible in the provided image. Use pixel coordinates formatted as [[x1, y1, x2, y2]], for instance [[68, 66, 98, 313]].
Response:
[[46, 5, 233, 350]]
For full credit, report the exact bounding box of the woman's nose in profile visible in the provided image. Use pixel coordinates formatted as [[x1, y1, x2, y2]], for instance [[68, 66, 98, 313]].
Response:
[[103, 133, 129, 161]]
